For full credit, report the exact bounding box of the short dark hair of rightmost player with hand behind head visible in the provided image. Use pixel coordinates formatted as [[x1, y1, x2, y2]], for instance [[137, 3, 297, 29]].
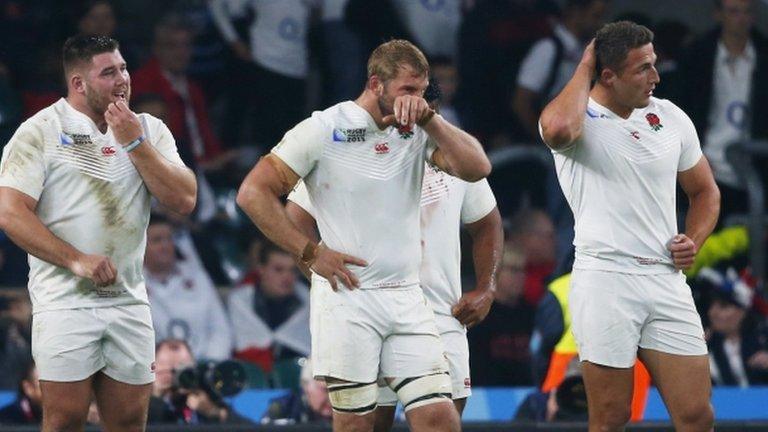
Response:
[[595, 21, 653, 77]]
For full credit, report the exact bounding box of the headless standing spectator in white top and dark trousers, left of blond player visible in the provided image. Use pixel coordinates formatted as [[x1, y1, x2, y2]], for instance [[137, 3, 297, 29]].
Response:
[[209, 0, 319, 149]]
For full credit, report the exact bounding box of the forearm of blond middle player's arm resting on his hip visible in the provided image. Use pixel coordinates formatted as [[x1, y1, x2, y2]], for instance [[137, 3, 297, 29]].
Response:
[[237, 179, 310, 257]]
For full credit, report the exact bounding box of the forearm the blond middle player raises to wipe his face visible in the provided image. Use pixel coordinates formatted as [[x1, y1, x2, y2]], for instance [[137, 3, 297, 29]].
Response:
[[424, 114, 491, 182]]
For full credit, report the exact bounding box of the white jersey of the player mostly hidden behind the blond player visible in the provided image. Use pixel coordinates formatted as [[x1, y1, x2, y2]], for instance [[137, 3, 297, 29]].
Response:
[[288, 166, 496, 316]]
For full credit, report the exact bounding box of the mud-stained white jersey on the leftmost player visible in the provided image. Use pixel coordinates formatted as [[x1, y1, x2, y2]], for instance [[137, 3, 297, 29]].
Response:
[[0, 99, 183, 312]]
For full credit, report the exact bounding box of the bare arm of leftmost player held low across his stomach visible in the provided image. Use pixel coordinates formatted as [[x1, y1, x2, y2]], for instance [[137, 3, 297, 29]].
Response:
[[0, 187, 117, 285]]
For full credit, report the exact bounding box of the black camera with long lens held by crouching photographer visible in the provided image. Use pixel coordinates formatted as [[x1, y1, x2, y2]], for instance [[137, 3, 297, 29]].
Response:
[[173, 360, 246, 401]]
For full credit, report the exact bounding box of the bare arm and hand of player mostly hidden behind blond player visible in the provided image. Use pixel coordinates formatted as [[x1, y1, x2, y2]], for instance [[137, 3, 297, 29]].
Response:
[[451, 207, 504, 327]]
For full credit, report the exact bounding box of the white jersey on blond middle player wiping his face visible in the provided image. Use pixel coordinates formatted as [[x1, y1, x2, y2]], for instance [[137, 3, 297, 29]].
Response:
[[272, 101, 435, 289]]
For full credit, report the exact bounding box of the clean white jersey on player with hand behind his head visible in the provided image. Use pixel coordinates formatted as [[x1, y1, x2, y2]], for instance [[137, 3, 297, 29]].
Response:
[[553, 98, 702, 274]]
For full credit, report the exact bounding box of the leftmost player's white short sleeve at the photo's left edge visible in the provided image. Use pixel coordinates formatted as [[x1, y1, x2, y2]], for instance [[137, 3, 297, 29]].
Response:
[[0, 120, 45, 200]]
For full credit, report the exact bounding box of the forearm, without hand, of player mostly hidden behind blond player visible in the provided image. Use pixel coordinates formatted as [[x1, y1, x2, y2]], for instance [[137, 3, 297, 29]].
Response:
[[468, 208, 504, 292]]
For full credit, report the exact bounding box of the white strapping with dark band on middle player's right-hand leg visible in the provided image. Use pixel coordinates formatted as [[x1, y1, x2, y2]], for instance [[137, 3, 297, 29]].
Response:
[[390, 372, 453, 413]]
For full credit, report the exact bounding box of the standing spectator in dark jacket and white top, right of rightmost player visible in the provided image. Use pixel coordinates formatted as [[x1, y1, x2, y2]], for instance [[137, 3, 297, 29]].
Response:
[[680, 0, 768, 222]]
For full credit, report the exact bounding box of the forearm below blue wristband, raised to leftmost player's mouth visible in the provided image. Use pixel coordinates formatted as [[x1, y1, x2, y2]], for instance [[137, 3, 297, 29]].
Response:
[[129, 142, 197, 214]]
